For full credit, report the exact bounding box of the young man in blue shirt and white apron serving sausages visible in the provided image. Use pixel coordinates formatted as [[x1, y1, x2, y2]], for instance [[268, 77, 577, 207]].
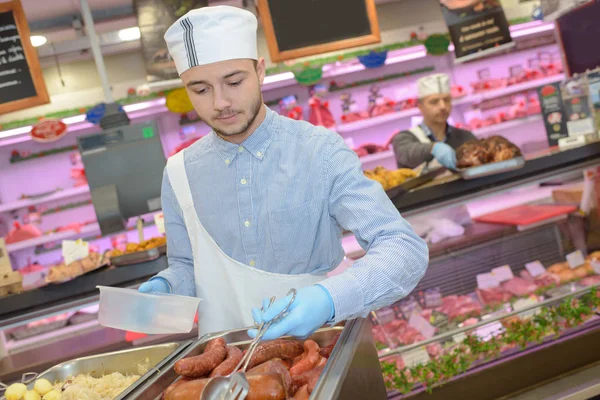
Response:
[[140, 6, 429, 339]]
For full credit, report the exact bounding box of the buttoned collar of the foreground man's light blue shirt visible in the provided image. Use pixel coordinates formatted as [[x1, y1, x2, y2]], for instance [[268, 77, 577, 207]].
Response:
[[210, 105, 275, 166]]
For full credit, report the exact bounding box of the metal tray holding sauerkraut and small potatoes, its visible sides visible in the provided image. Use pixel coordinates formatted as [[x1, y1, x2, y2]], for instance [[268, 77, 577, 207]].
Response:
[[28, 341, 192, 399]]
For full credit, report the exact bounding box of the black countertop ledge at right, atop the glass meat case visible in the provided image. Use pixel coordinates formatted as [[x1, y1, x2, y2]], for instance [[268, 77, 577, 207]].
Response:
[[392, 142, 600, 217]]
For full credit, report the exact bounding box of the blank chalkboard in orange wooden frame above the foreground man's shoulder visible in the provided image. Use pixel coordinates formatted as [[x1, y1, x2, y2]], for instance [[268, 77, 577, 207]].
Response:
[[258, 0, 381, 62]]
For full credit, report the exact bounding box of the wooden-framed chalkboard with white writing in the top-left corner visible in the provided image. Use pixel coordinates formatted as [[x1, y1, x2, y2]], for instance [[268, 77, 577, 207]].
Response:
[[0, 0, 49, 114]]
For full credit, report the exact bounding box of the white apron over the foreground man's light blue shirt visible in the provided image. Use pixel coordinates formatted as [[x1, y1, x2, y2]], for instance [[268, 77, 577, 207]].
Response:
[[167, 150, 326, 336]]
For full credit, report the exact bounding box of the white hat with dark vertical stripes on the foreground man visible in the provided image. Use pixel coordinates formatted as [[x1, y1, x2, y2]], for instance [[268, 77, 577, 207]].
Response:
[[165, 6, 258, 75]]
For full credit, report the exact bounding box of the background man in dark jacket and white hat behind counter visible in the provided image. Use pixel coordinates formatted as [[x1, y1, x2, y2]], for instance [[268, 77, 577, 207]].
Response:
[[392, 74, 476, 169]]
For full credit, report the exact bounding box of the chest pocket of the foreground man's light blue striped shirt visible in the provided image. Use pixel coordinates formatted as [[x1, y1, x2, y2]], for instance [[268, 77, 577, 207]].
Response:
[[269, 201, 320, 262]]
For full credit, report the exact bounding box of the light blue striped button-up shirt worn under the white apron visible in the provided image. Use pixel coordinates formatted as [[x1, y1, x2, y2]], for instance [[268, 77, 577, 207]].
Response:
[[158, 108, 429, 322]]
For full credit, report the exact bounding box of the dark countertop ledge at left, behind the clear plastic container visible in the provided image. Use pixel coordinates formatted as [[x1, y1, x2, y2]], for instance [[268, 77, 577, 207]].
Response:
[[0, 257, 168, 329]]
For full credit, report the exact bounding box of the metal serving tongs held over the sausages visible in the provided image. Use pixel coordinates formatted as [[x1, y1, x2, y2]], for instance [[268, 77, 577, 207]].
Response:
[[200, 289, 296, 400]]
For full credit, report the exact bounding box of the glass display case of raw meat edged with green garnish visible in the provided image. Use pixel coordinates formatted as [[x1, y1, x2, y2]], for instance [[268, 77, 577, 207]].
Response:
[[353, 143, 600, 399]]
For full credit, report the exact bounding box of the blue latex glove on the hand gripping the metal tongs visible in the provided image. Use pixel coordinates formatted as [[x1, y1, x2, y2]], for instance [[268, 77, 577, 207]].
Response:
[[248, 285, 334, 340]]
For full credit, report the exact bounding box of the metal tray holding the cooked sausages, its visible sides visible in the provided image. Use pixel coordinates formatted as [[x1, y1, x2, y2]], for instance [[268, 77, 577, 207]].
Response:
[[123, 318, 387, 400]]
